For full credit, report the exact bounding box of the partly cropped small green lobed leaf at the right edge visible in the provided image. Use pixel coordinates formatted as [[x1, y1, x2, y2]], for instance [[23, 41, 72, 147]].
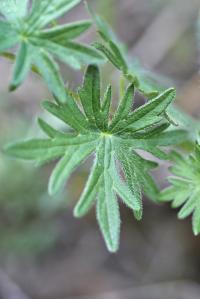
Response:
[[160, 144, 200, 235]]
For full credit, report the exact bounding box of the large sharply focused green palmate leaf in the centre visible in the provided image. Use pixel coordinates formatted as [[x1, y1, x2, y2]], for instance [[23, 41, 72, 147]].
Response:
[[7, 65, 186, 252]]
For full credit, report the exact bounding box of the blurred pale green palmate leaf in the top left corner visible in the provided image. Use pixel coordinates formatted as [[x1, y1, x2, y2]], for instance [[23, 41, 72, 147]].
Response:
[[0, 0, 104, 102]]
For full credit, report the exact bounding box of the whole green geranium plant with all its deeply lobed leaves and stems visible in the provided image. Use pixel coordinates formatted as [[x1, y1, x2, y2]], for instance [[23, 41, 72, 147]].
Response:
[[0, 0, 200, 252]]
